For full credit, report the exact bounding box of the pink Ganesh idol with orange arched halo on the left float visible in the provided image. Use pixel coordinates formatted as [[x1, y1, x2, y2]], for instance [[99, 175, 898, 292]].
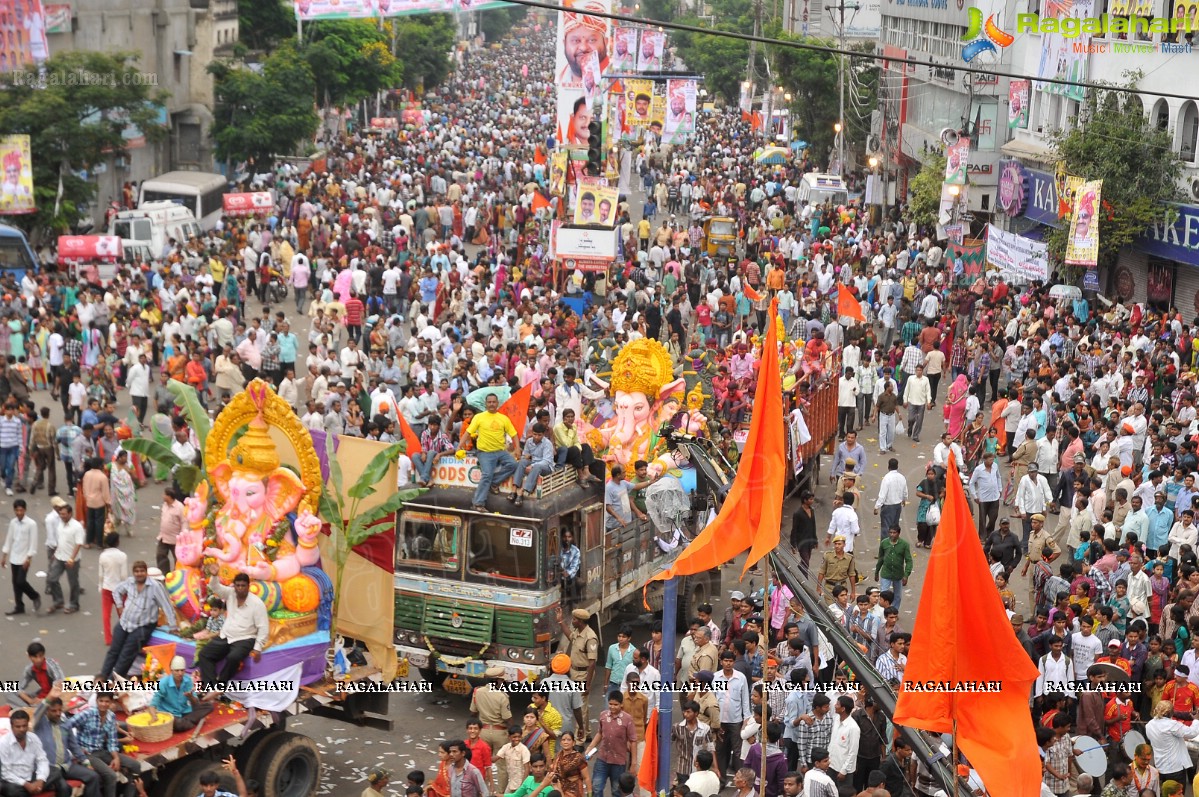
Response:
[[167, 380, 330, 641]]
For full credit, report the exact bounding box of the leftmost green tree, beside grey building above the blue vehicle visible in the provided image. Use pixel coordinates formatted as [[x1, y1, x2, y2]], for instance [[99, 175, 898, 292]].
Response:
[[0, 50, 167, 233]]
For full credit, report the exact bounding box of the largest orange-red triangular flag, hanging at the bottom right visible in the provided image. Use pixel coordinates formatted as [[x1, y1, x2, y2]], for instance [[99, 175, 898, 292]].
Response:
[[894, 454, 1041, 797]]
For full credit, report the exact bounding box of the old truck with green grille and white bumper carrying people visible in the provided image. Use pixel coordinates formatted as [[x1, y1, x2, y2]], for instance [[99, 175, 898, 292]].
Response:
[[396, 427, 731, 694]]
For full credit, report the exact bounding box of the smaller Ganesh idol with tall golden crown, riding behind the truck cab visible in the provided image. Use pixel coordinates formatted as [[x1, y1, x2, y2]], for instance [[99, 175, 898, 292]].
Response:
[[588, 338, 707, 476]]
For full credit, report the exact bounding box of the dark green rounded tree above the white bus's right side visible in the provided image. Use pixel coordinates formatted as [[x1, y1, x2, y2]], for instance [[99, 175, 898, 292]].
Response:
[[209, 40, 320, 167]]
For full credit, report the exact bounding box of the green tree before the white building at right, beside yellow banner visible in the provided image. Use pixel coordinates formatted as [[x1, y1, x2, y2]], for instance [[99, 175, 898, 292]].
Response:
[[1046, 73, 1182, 277]]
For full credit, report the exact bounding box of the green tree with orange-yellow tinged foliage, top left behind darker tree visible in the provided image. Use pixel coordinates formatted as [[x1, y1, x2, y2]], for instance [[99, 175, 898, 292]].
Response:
[[300, 19, 403, 108]]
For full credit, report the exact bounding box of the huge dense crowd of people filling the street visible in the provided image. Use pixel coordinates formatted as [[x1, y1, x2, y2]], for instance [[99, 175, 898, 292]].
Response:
[[0, 9, 1199, 797]]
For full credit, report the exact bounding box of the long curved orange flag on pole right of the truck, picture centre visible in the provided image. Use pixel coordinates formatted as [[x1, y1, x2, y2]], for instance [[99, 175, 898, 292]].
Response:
[[650, 300, 787, 581]]
